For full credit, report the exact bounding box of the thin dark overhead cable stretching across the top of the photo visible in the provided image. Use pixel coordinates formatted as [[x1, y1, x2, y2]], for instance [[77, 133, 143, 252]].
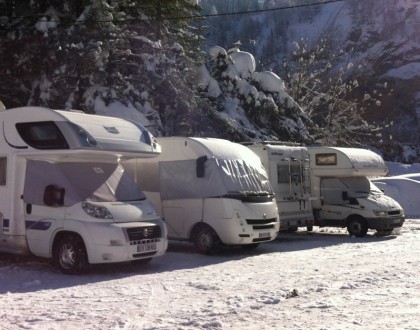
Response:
[[0, 0, 345, 23]]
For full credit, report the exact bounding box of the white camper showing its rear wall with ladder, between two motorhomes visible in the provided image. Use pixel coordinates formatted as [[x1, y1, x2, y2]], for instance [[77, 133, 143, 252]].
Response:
[[243, 142, 314, 232]]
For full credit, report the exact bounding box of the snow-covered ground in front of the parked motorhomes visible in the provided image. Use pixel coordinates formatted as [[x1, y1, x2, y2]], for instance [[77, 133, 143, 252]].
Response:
[[0, 164, 420, 330]]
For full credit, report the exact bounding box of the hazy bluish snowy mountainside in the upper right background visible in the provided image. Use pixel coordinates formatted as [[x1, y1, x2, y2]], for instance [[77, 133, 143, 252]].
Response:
[[202, 0, 420, 161]]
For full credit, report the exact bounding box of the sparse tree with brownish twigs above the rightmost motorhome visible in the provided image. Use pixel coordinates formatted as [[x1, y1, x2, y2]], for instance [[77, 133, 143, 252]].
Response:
[[283, 40, 387, 146]]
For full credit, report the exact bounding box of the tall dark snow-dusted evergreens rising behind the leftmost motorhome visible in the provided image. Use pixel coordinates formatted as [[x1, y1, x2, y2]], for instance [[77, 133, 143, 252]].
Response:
[[0, 0, 205, 134]]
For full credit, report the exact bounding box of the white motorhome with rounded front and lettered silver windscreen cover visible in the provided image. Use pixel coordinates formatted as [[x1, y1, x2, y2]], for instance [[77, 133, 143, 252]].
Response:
[[124, 137, 279, 253]]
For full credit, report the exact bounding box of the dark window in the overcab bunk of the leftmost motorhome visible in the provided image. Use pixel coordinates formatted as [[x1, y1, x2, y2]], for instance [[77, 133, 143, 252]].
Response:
[[16, 121, 69, 149]]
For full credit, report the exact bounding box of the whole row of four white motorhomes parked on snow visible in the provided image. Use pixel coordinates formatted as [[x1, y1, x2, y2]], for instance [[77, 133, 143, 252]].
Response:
[[0, 107, 404, 274]]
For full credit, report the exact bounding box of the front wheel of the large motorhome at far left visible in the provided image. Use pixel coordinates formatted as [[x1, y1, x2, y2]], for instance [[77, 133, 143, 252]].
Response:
[[53, 235, 89, 275]]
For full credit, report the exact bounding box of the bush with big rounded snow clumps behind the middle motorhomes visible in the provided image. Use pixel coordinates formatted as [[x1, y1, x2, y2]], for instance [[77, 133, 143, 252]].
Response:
[[199, 46, 312, 142]]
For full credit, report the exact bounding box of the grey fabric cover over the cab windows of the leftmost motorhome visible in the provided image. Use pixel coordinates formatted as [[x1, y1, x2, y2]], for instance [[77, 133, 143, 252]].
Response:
[[24, 160, 145, 206]]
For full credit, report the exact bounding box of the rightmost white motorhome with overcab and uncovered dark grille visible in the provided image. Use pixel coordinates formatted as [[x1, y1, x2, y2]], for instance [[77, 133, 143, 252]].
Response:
[[308, 147, 404, 237]]
